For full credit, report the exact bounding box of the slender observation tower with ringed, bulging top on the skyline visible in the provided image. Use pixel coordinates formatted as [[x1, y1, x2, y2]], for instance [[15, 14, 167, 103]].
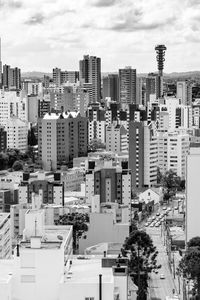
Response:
[[155, 45, 167, 97]]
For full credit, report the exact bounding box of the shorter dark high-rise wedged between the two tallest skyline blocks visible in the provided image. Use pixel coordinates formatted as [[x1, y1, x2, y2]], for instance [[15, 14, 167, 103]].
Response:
[[103, 74, 119, 102]]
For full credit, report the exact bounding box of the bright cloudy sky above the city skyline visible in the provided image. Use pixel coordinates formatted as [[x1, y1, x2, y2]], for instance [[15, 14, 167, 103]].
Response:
[[0, 0, 200, 73]]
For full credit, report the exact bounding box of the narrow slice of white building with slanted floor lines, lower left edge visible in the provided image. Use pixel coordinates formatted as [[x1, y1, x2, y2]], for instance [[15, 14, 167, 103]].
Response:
[[0, 213, 12, 259]]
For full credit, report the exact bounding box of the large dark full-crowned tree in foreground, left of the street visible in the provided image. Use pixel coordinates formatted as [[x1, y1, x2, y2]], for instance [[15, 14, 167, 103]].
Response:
[[121, 230, 161, 300]]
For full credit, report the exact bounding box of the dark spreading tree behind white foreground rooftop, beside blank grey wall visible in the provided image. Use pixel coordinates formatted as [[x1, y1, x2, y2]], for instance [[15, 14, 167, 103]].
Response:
[[55, 213, 89, 253]]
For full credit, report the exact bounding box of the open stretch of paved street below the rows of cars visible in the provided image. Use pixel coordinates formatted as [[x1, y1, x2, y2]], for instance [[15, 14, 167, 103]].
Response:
[[146, 227, 182, 300]]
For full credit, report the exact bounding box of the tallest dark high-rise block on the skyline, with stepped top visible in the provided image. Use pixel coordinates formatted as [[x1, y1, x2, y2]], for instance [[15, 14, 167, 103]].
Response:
[[79, 55, 101, 102]]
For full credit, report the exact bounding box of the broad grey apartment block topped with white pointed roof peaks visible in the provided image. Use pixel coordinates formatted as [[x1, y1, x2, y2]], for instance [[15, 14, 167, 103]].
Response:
[[38, 112, 88, 170]]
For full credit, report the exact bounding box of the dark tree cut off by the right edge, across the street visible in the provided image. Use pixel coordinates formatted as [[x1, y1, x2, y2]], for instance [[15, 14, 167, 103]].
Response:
[[177, 237, 200, 300]]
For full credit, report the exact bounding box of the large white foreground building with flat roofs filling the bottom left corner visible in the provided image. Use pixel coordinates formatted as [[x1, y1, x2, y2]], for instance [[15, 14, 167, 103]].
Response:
[[0, 206, 132, 300]]
